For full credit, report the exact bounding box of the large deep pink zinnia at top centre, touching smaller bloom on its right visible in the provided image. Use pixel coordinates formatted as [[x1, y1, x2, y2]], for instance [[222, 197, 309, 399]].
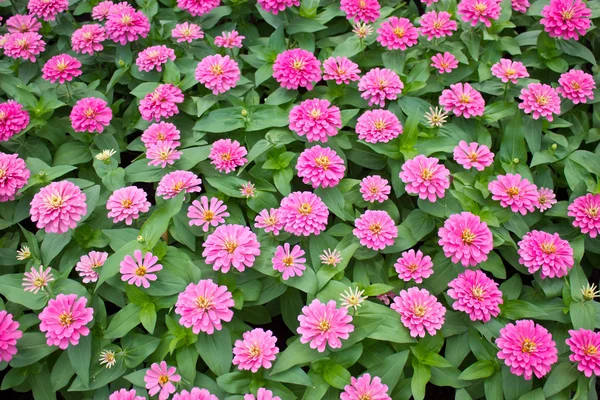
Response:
[[273, 49, 321, 90]]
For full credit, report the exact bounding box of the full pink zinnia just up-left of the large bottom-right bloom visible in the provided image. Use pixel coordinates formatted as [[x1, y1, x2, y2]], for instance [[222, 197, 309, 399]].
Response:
[[448, 270, 504, 322]]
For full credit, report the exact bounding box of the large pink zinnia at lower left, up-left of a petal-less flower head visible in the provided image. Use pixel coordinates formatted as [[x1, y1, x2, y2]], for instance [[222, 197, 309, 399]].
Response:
[[38, 293, 94, 350]]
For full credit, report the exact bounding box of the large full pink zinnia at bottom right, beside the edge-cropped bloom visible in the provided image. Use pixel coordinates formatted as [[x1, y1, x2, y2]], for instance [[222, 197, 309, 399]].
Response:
[[496, 319, 558, 380]]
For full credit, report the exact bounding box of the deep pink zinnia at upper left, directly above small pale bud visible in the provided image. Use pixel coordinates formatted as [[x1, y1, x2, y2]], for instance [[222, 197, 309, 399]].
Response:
[[69, 97, 112, 133]]
